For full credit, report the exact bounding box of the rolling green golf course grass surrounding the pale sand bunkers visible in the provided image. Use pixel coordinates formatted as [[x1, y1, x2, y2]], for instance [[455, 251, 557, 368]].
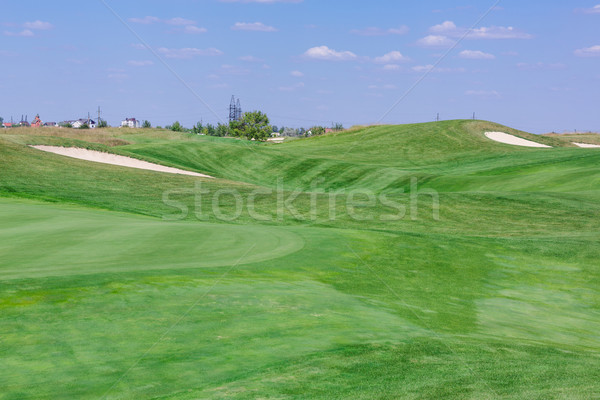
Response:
[[0, 121, 600, 399]]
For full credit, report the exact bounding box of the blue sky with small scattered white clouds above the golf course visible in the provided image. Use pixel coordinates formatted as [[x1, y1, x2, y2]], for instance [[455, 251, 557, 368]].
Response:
[[0, 0, 600, 133]]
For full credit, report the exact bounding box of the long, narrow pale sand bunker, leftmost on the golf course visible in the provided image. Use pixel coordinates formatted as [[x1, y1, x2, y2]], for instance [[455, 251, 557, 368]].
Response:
[[31, 146, 212, 178]]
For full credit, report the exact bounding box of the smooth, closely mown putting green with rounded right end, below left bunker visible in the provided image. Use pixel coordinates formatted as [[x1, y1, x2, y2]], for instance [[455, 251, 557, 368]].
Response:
[[0, 199, 304, 279]]
